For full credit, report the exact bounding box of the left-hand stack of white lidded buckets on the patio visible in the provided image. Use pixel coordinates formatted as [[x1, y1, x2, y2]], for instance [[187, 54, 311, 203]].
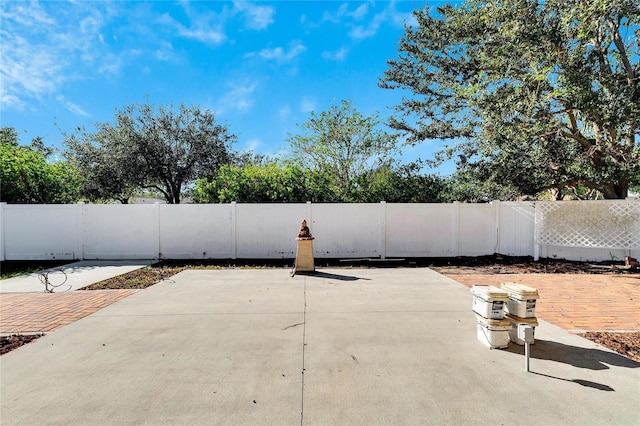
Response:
[[471, 285, 511, 348]]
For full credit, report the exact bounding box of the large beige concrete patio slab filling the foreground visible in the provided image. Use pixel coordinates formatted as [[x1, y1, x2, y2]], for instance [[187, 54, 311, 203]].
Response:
[[0, 268, 640, 425]]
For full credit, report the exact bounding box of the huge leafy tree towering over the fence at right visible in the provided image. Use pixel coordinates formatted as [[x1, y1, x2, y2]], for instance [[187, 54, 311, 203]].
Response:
[[380, 0, 640, 198]]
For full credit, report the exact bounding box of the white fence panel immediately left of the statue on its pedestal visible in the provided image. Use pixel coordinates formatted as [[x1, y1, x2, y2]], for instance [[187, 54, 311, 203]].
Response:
[[235, 204, 313, 259]]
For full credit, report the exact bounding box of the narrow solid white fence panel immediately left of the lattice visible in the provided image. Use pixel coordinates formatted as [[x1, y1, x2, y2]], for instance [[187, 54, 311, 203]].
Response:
[[496, 202, 535, 256]]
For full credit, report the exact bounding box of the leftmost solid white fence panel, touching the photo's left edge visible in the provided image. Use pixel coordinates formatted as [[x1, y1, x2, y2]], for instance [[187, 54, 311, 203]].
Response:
[[0, 204, 81, 260]]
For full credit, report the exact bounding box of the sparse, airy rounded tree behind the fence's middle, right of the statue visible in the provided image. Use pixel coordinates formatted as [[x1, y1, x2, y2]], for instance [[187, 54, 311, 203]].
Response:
[[288, 100, 397, 202]]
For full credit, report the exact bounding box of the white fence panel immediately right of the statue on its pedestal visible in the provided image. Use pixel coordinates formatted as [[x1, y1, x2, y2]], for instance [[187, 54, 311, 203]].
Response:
[[310, 204, 383, 258]]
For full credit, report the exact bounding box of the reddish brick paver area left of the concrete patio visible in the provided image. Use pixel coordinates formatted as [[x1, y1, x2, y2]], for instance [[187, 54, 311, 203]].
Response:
[[0, 290, 138, 334]]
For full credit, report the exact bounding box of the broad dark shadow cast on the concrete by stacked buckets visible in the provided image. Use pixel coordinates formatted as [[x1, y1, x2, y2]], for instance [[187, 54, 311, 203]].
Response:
[[507, 339, 640, 370]]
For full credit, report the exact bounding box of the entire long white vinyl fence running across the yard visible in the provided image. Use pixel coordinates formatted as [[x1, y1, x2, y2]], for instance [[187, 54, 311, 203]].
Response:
[[0, 201, 640, 261]]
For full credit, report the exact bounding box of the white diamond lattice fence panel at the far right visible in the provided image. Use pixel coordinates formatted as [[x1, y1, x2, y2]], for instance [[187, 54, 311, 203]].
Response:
[[535, 200, 640, 249]]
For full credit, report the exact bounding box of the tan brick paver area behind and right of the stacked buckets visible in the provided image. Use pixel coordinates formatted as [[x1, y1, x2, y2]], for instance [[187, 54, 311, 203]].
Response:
[[449, 274, 640, 331]]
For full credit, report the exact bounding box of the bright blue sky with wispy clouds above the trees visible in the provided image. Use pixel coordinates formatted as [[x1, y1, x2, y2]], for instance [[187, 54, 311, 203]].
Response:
[[0, 0, 452, 174]]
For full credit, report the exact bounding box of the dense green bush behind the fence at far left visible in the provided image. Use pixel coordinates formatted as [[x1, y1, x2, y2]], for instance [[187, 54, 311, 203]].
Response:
[[0, 127, 81, 204]]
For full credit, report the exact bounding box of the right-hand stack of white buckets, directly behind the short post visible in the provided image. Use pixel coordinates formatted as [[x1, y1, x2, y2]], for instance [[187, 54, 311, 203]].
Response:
[[500, 283, 539, 345]]
